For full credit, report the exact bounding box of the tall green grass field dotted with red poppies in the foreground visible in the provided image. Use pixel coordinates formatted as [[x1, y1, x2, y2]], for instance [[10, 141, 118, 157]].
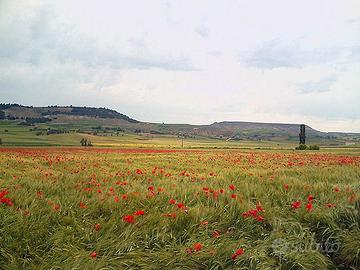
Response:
[[0, 148, 360, 269]]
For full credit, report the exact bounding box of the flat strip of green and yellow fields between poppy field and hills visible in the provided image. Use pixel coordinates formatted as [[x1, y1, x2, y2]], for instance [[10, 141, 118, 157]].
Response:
[[0, 119, 360, 149]]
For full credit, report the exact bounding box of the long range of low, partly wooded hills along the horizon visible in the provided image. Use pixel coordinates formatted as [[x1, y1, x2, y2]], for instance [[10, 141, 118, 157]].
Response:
[[0, 104, 360, 145]]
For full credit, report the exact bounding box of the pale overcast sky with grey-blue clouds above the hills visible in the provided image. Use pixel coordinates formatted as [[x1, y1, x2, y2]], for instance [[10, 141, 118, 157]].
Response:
[[0, 0, 360, 132]]
